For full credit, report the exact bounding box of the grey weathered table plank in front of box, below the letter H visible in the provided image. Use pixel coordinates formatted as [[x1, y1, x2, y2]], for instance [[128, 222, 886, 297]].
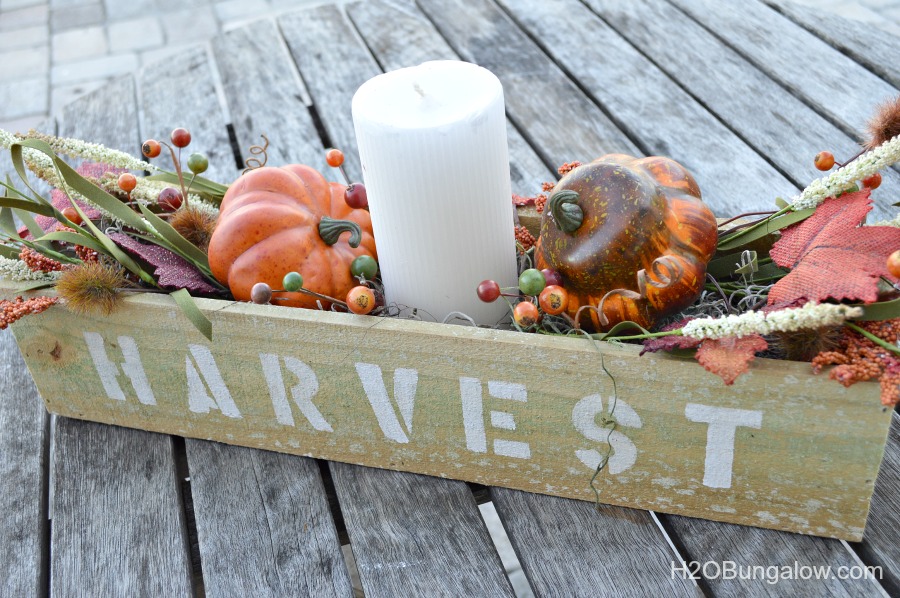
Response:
[[50, 417, 193, 596]]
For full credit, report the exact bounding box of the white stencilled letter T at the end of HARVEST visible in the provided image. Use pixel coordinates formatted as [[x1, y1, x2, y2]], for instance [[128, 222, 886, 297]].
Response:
[[684, 403, 762, 488]]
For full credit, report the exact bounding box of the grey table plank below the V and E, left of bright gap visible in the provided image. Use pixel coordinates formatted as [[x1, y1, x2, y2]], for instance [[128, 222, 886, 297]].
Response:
[[330, 463, 513, 597]]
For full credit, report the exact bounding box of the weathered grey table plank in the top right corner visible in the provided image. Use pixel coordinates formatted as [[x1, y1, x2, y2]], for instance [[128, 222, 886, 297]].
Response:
[[764, 0, 900, 89]]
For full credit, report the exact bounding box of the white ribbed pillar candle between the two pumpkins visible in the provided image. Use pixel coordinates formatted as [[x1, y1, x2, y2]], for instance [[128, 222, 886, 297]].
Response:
[[353, 61, 516, 324]]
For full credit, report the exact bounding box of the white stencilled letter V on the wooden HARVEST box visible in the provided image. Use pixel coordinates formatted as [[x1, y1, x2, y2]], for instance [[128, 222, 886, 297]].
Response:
[[356, 363, 419, 444]]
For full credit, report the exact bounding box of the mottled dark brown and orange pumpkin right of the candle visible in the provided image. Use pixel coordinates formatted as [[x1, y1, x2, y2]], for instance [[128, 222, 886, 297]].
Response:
[[535, 154, 718, 330]]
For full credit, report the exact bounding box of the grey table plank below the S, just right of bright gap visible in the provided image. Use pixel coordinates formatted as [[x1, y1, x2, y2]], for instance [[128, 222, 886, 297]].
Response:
[[491, 488, 701, 598]]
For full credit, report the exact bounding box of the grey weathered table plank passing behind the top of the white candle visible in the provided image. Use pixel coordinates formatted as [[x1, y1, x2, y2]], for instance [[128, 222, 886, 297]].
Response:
[[347, 0, 558, 196]]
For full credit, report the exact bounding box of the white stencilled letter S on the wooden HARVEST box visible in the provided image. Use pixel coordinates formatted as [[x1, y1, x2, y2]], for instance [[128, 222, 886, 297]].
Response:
[[572, 395, 643, 474]]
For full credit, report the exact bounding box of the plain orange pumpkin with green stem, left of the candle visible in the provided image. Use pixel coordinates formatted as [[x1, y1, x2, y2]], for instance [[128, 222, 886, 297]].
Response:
[[209, 164, 377, 309]]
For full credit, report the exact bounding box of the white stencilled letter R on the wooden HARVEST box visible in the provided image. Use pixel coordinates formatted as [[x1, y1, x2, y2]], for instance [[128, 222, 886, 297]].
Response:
[[259, 353, 334, 432]]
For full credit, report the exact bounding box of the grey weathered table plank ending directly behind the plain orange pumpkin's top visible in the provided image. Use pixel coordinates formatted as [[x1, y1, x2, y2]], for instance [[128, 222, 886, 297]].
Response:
[[212, 20, 328, 180]]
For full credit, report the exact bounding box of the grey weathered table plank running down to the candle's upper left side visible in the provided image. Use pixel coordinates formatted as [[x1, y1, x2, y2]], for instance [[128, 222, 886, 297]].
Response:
[[278, 5, 381, 181]]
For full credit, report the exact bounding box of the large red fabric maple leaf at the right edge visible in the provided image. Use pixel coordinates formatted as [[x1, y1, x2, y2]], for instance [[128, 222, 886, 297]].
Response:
[[769, 189, 900, 304]]
